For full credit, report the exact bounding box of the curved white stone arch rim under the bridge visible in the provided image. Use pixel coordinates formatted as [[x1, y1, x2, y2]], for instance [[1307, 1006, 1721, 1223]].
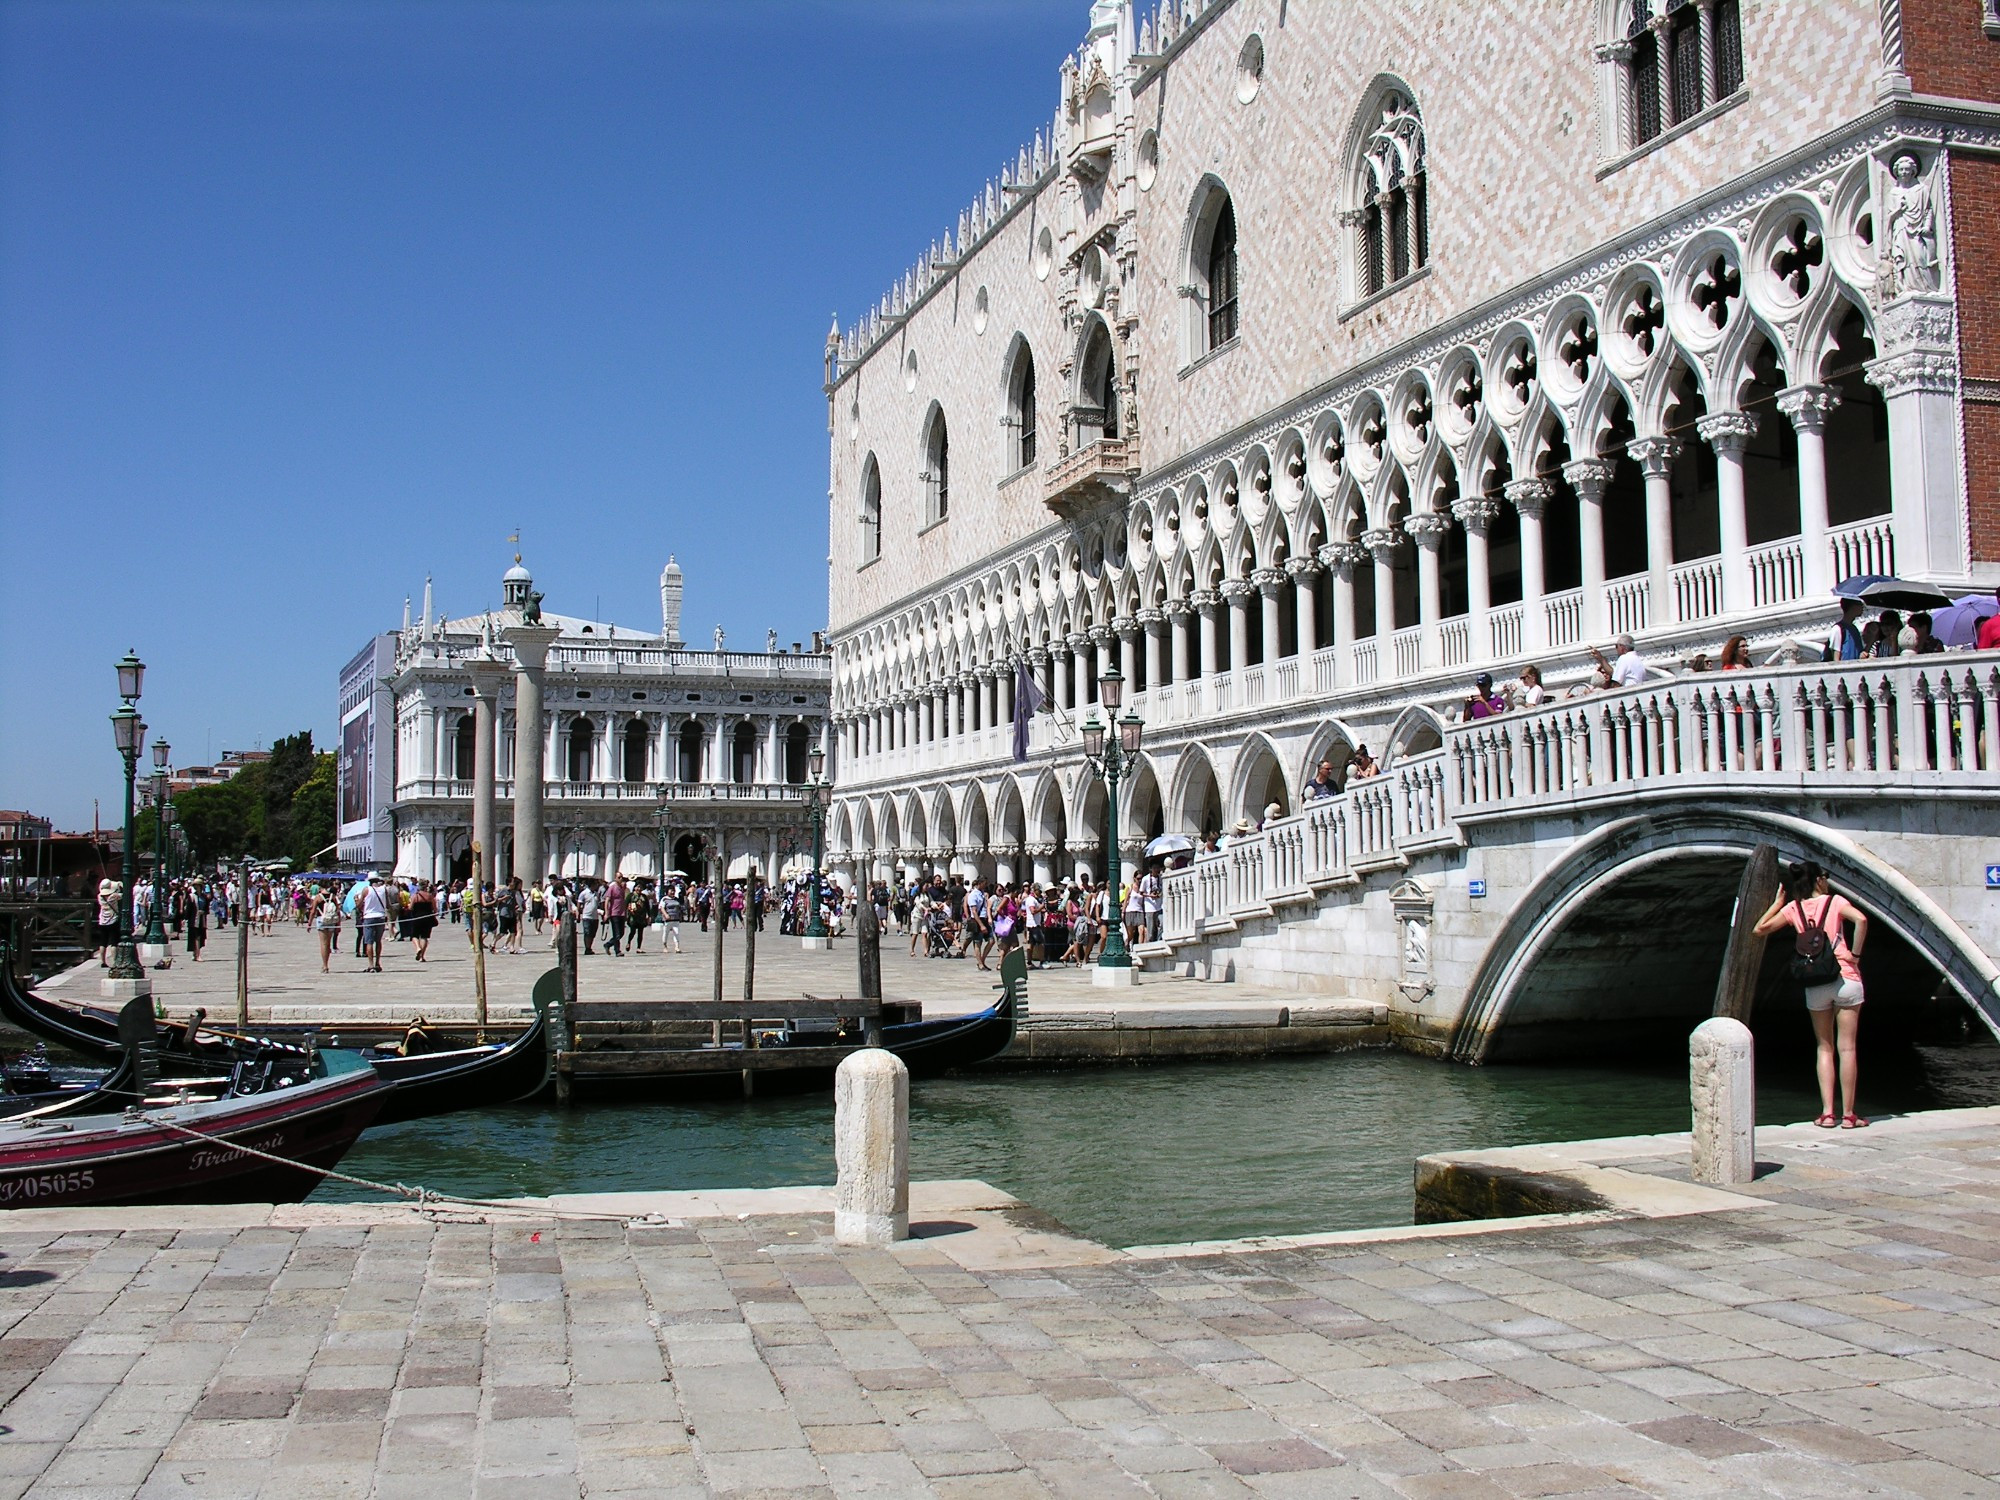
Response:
[[1450, 802, 2000, 1062]]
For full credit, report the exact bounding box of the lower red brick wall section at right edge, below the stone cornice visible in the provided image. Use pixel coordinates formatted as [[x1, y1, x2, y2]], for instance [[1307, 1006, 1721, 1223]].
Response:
[[1952, 154, 2000, 562]]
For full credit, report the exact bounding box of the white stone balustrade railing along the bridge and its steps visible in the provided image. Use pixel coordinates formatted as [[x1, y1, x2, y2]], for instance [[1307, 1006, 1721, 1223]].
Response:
[[1162, 652, 2000, 942]]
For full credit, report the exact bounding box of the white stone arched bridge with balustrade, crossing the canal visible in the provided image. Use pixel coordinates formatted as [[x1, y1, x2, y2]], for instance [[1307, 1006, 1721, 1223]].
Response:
[[1140, 652, 2000, 1060]]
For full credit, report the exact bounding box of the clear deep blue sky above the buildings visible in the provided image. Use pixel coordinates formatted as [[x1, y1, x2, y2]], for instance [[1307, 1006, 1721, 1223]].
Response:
[[0, 0, 1088, 828]]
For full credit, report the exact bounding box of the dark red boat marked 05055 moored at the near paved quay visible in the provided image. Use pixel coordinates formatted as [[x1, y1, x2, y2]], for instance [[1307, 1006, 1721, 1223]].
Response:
[[0, 1054, 394, 1208]]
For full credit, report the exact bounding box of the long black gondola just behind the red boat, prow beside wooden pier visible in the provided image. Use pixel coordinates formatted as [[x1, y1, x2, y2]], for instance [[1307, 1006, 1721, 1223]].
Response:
[[0, 948, 560, 1124]]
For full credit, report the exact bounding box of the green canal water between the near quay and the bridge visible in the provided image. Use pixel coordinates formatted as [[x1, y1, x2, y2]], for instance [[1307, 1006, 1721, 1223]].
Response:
[[314, 1044, 2000, 1246]]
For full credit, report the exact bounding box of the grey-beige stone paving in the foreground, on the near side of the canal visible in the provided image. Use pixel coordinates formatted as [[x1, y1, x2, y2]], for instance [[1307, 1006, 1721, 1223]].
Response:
[[0, 1110, 2000, 1500]]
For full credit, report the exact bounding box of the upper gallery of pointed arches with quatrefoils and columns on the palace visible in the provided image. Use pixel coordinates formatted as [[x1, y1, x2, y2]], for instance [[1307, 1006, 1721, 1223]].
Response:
[[834, 158, 1894, 778]]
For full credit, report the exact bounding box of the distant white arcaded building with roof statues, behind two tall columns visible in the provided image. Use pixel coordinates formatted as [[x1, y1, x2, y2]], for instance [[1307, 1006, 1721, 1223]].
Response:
[[340, 558, 828, 882]]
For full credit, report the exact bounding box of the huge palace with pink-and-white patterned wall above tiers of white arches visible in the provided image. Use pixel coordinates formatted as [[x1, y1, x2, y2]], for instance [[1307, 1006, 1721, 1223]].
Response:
[[826, 0, 2000, 912]]
